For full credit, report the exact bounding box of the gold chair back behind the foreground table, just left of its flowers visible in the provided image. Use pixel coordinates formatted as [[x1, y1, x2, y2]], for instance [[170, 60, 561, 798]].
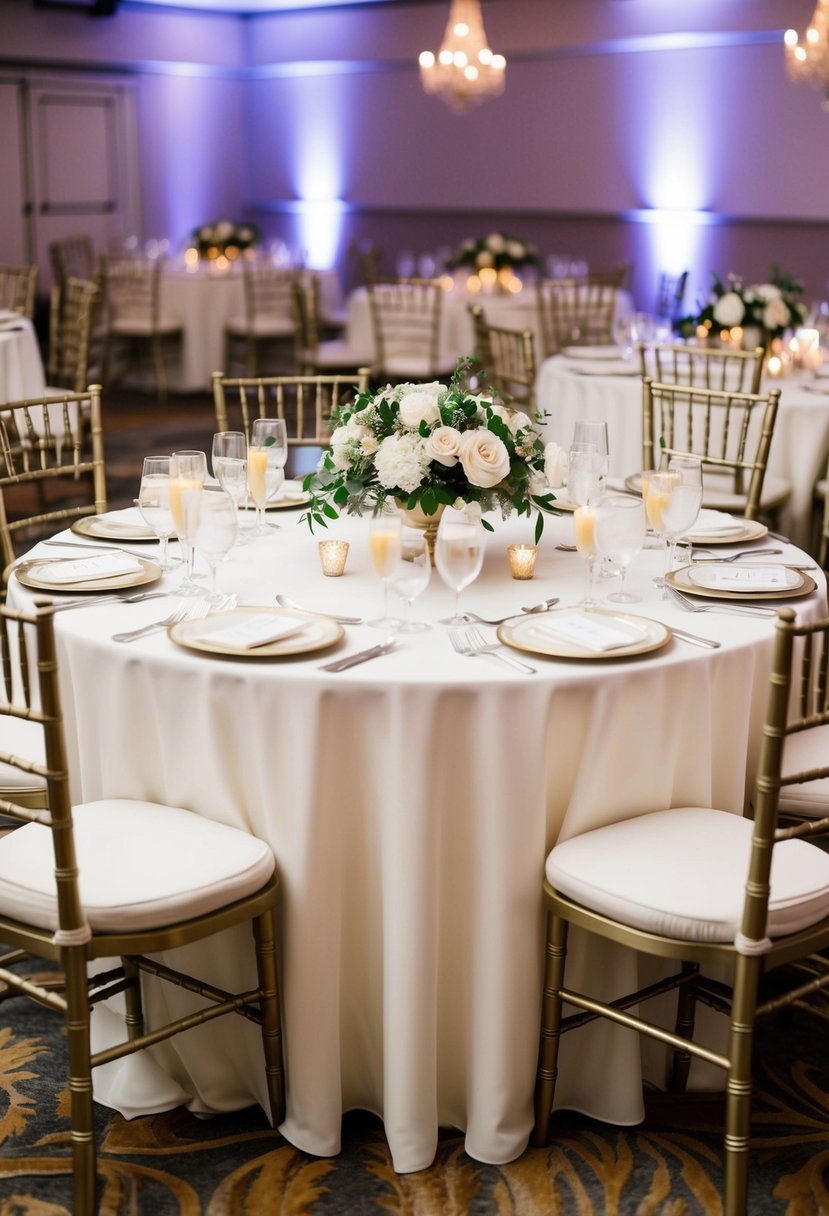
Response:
[[213, 367, 368, 447]]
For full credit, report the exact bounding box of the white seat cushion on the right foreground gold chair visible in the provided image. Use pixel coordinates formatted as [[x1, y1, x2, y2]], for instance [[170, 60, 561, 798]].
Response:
[[546, 806, 829, 941]]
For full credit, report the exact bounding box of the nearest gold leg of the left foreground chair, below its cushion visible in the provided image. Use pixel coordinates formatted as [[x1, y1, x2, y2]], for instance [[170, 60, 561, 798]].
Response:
[[63, 947, 97, 1216]]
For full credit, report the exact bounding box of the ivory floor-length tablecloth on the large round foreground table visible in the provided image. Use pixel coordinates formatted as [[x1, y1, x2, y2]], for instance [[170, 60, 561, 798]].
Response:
[[9, 500, 827, 1172]]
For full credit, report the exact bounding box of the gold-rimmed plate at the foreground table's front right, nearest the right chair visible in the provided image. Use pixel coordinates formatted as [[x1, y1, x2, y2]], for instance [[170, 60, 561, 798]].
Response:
[[497, 608, 671, 660]]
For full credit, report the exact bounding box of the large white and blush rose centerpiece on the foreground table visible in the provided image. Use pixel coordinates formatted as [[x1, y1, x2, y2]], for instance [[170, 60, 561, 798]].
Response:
[[301, 359, 560, 539]]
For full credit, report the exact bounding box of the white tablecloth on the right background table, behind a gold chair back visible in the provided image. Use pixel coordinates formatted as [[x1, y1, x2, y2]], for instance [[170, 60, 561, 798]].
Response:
[[536, 355, 829, 546]]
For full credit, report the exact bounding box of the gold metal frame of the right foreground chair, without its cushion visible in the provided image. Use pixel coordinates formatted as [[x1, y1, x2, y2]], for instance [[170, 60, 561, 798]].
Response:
[[532, 608, 829, 1216]]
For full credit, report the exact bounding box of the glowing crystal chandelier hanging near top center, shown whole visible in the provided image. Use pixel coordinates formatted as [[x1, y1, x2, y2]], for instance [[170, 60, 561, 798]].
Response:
[[418, 0, 507, 111]]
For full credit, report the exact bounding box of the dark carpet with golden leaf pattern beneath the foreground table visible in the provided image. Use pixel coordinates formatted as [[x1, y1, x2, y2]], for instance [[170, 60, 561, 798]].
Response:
[[0, 967, 829, 1216]]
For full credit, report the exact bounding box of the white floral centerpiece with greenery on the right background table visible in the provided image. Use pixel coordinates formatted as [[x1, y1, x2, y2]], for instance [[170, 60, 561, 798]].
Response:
[[679, 265, 806, 347]]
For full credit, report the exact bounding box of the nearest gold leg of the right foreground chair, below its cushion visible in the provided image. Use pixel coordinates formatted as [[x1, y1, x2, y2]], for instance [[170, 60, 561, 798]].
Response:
[[723, 955, 760, 1216]]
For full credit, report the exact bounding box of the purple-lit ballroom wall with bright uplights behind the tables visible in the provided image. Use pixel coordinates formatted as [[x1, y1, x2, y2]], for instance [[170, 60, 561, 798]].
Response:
[[0, 0, 829, 306]]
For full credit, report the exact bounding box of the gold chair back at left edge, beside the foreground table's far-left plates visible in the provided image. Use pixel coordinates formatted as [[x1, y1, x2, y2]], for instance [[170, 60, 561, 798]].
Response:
[[0, 384, 107, 574]]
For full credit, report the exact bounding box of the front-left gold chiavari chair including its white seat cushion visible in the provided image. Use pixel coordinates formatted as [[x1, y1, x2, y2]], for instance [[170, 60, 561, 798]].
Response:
[[0, 608, 284, 1216]]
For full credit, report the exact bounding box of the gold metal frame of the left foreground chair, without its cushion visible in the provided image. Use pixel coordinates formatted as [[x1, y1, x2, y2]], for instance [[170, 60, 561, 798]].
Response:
[[0, 608, 284, 1216]]
